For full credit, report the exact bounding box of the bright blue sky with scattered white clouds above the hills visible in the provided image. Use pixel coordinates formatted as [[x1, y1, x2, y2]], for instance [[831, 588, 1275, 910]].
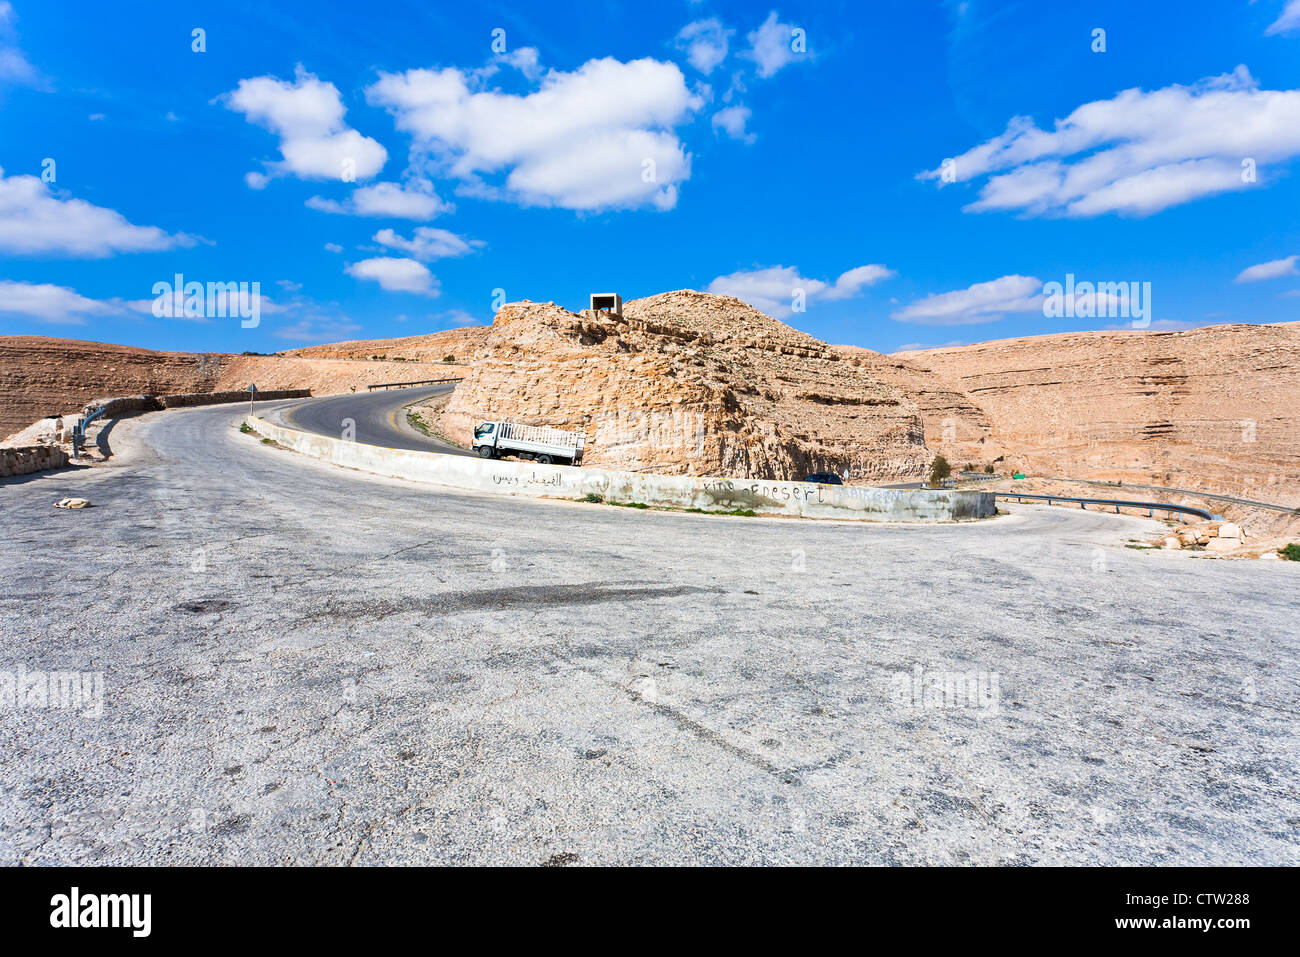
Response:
[[0, 0, 1300, 351]]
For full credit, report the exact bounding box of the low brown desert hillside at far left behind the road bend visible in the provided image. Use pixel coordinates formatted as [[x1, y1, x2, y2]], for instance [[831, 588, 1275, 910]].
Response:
[[0, 335, 459, 437]]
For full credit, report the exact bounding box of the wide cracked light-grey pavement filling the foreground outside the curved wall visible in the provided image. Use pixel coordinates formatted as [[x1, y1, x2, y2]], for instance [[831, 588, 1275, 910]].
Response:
[[0, 407, 1300, 865]]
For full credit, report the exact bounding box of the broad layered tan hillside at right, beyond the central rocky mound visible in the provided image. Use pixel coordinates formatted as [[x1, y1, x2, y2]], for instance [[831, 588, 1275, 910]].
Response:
[[892, 322, 1300, 503]]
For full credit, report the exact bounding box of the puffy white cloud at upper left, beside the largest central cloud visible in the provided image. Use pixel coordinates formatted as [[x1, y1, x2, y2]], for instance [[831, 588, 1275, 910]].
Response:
[[217, 65, 389, 189]]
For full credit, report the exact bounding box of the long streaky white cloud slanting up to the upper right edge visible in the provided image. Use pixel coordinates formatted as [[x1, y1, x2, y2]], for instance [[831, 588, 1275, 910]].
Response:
[[919, 66, 1300, 217]]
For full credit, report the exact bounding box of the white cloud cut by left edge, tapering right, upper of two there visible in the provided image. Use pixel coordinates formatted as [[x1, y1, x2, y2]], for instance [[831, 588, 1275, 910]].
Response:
[[0, 169, 195, 259]]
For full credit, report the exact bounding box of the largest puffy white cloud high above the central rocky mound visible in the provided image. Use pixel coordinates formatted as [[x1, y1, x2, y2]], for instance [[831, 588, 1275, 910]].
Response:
[[367, 57, 702, 209]]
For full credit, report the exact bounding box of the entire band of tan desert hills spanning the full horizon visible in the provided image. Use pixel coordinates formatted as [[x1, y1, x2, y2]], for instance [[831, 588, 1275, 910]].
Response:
[[12, 312, 1300, 503]]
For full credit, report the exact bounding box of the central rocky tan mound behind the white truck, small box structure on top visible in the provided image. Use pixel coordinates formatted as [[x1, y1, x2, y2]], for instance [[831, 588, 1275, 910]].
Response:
[[441, 290, 932, 481]]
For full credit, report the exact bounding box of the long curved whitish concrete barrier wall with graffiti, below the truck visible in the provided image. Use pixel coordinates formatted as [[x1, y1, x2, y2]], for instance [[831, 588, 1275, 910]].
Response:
[[248, 417, 996, 521]]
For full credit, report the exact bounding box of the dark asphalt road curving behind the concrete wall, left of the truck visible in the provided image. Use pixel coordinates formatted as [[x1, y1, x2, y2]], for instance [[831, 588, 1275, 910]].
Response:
[[264, 385, 471, 455]]
